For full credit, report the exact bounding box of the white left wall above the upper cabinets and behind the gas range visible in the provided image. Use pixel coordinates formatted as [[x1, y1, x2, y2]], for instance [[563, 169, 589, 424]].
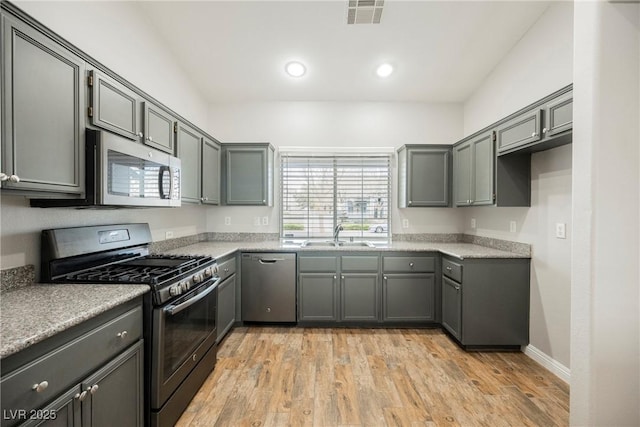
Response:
[[0, 1, 207, 269]]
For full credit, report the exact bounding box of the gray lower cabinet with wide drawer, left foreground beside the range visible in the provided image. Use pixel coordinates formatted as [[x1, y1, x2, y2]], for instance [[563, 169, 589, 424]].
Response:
[[0, 299, 144, 427]]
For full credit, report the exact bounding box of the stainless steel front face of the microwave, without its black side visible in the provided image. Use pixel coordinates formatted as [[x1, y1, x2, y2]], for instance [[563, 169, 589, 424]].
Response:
[[96, 132, 180, 207]]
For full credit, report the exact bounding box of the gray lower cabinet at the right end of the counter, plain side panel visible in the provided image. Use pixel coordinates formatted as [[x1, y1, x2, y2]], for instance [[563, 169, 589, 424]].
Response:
[[442, 256, 530, 348]]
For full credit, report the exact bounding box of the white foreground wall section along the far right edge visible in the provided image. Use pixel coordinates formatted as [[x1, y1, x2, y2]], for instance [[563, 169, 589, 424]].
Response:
[[571, 2, 640, 426]]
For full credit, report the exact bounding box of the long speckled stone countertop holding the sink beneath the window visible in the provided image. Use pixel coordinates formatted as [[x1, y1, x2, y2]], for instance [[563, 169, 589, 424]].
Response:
[[165, 241, 531, 259]]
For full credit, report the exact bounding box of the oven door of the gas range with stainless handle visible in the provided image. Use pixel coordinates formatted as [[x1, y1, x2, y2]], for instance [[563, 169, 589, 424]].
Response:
[[151, 278, 220, 410]]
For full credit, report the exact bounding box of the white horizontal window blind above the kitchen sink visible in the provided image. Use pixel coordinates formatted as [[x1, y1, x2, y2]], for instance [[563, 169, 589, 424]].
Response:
[[280, 153, 391, 239]]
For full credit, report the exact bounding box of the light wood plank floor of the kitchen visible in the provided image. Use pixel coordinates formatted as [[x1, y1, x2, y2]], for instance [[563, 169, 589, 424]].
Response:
[[177, 327, 569, 427]]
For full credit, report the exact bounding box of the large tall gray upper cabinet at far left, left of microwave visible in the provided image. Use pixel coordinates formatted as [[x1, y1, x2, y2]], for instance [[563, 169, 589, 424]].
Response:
[[1, 11, 85, 195]]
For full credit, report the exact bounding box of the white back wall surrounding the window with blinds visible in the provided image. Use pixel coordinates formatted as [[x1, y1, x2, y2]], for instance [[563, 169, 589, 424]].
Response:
[[207, 102, 462, 233]]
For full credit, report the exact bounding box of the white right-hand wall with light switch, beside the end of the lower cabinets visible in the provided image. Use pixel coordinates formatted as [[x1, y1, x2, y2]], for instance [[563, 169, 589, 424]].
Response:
[[460, 2, 573, 380]]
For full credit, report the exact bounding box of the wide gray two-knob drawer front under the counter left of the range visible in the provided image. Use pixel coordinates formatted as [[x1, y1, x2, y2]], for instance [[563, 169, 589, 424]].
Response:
[[0, 307, 142, 418]]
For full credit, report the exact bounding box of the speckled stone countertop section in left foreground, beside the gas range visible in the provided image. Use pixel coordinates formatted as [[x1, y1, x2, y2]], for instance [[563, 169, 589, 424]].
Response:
[[0, 284, 149, 358]]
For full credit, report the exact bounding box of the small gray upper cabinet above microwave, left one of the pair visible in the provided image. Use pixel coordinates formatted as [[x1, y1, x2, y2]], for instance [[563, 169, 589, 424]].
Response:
[[89, 70, 142, 140]]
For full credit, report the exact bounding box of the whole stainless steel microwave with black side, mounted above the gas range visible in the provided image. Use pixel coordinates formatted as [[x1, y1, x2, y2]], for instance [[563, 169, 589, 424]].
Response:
[[31, 129, 181, 208]]
